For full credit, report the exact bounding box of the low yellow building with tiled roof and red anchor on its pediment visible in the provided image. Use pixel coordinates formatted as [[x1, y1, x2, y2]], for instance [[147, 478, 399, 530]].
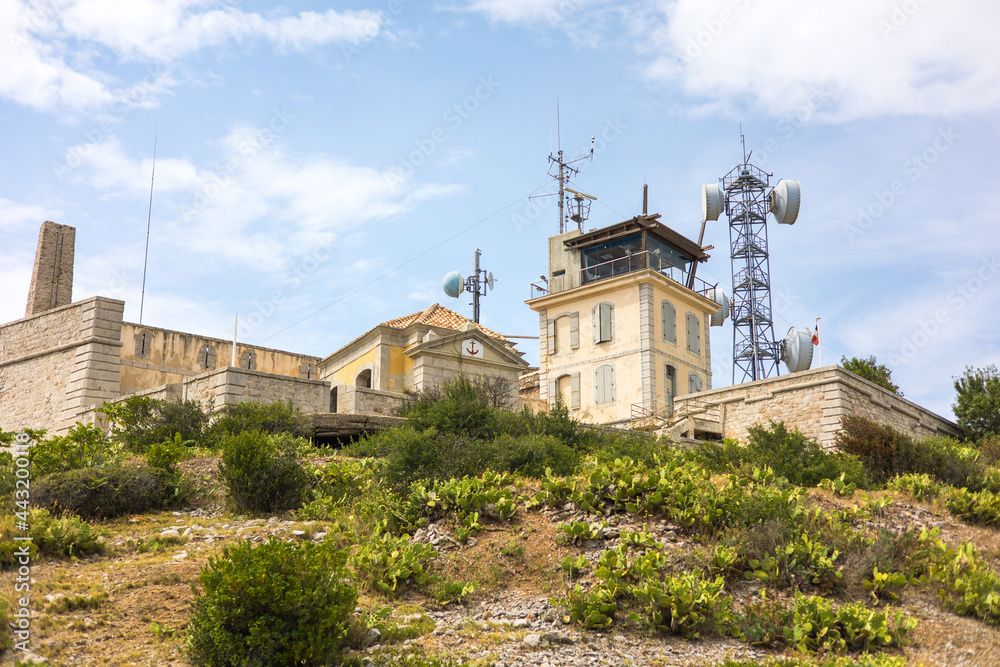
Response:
[[319, 304, 528, 413]]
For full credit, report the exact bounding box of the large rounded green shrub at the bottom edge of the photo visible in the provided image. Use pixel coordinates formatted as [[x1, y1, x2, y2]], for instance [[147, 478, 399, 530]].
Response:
[[187, 540, 357, 667]]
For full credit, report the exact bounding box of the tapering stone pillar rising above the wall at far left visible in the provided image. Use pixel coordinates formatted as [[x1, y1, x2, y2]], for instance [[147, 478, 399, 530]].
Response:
[[24, 221, 76, 317]]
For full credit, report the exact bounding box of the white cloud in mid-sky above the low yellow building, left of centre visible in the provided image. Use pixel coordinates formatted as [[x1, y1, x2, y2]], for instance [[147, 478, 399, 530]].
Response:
[[67, 123, 458, 273]]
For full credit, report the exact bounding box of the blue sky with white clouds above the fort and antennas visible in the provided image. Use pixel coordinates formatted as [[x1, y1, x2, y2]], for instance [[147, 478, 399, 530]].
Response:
[[0, 0, 1000, 417]]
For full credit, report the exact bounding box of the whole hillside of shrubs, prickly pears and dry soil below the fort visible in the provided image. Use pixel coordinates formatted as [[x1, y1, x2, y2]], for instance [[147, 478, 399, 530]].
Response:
[[0, 378, 1000, 667]]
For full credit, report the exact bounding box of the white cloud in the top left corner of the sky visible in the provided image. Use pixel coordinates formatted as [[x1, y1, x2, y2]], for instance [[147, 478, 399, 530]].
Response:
[[0, 0, 385, 111]]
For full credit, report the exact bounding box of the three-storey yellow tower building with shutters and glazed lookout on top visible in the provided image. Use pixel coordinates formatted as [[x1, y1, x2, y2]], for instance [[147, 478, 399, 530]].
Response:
[[527, 215, 721, 424]]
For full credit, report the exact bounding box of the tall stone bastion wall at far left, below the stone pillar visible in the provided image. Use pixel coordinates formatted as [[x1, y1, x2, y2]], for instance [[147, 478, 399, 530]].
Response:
[[0, 297, 125, 434]]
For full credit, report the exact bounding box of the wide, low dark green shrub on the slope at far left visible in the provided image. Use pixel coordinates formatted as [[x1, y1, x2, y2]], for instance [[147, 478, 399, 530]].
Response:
[[31, 465, 170, 519]]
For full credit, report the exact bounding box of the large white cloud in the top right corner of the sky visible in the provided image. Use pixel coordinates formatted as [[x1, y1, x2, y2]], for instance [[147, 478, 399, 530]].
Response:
[[631, 0, 1000, 120]]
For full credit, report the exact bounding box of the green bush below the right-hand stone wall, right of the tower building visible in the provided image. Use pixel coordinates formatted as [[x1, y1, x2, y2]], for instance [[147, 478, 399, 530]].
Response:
[[694, 421, 868, 487]]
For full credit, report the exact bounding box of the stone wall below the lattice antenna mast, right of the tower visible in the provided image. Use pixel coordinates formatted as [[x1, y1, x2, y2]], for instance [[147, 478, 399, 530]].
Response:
[[674, 366, 959, 447]]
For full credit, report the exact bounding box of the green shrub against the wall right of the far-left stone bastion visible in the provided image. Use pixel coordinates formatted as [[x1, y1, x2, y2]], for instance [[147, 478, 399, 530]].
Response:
[[101, 396, 209, 454]]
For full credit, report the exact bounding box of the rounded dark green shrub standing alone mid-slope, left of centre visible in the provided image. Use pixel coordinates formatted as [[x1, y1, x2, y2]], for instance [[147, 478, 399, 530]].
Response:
[[219, 431, 309, 512]]
